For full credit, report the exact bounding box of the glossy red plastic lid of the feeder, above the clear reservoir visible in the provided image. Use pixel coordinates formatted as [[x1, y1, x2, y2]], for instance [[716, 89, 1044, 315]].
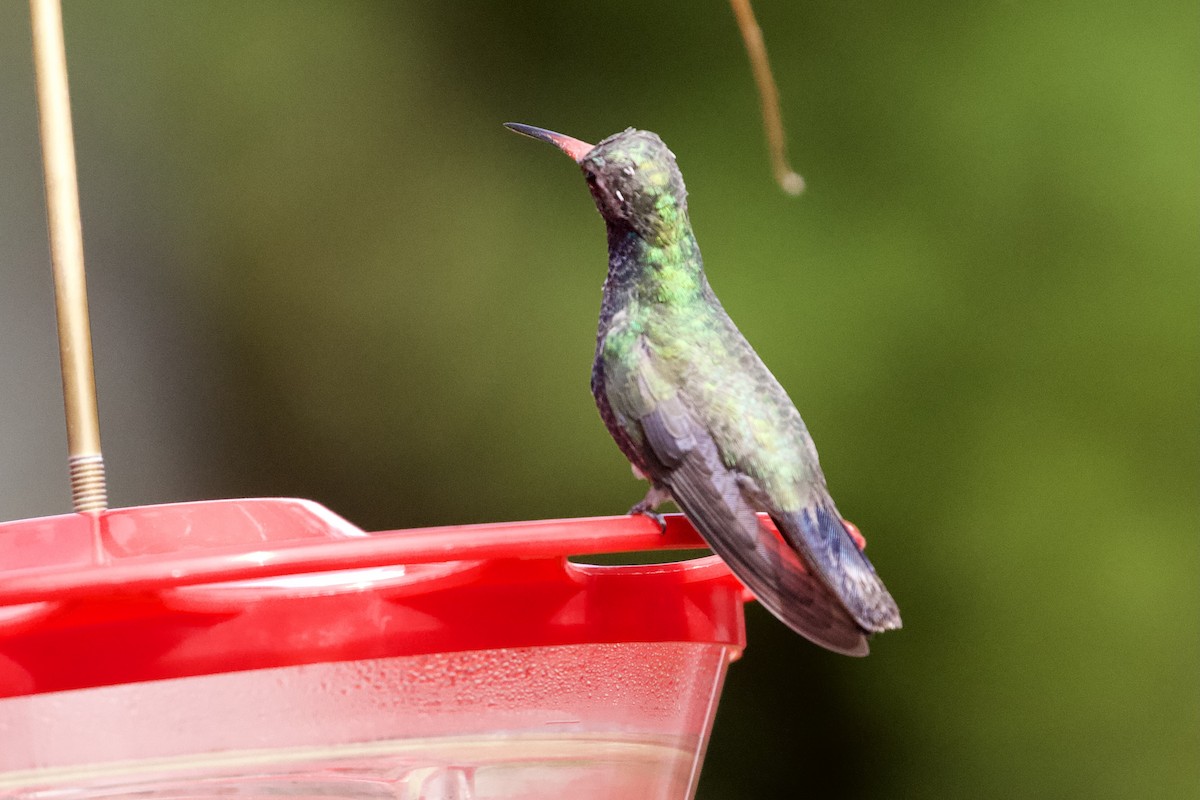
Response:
[[0, 499, 746, 697]]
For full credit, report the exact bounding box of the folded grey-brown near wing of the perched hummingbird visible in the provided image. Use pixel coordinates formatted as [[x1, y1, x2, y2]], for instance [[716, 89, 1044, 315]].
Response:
[[608, 348, 869, 656]]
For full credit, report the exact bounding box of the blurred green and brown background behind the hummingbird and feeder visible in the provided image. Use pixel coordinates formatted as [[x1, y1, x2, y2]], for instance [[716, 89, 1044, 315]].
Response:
[[0, 0, 1200, 800]]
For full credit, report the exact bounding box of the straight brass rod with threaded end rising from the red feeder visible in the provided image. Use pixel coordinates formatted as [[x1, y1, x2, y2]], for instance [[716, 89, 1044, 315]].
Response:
[[29, 0, 108, 511]]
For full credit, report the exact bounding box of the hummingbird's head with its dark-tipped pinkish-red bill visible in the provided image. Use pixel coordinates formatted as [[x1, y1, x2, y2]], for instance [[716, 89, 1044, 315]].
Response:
[[506, 122, 689, 246]]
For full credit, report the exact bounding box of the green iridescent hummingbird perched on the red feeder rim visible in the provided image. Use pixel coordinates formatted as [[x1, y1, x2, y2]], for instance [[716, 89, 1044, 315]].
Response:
[[505, 122, 900, 656]]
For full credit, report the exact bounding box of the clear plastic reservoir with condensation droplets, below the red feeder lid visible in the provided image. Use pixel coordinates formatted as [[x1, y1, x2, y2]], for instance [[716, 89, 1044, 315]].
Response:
[[0, 642, 737, 800]]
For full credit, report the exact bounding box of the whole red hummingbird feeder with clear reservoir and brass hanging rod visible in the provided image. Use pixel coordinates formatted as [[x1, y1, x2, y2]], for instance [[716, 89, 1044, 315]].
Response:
[[0, 0, 868, 800]]
